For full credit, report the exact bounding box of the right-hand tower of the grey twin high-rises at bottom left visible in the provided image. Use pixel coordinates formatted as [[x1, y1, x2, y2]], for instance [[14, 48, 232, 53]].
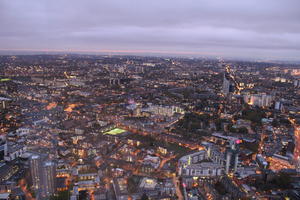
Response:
[[43, 161, 56, 196]]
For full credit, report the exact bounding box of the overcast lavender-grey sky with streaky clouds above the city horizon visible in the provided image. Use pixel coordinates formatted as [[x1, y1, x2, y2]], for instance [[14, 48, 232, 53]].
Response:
[[0, 0, 300, 61]]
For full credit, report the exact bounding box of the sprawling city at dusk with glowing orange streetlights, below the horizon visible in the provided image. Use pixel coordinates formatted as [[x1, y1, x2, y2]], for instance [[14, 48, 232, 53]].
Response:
[[0, 55, 300, 200]]
